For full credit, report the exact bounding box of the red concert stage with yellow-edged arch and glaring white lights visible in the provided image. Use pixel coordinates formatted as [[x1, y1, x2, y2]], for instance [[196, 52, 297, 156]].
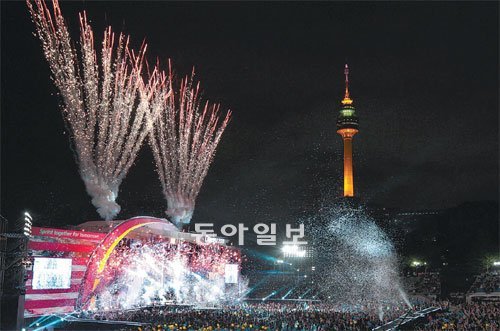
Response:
[[24, 217, 241, 318]]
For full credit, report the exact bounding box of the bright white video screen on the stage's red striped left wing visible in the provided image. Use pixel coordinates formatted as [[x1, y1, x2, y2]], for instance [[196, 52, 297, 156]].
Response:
[[32, 257, 72, 290]]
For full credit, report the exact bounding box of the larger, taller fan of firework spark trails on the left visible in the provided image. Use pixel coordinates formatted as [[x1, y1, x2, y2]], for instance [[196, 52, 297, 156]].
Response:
[[27, 0, 162, 220]]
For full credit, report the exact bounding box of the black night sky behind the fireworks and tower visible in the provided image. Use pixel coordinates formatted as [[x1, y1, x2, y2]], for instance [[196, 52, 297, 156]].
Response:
[[1, 1, 499, 231]]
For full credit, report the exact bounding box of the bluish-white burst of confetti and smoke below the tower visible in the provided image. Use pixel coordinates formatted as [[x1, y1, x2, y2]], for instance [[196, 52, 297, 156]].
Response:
[[311, 206, 408, 316]]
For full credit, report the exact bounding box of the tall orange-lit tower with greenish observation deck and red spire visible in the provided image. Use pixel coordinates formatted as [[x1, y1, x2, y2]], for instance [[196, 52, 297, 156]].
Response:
[[337, 64, 358, 197]]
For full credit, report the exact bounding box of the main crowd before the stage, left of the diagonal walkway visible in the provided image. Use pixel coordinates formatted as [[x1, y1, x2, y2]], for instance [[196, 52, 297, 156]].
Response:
[[81, 302, 421, 331]]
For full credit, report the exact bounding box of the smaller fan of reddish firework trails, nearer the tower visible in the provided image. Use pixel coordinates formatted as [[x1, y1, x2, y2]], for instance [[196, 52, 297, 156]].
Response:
[[149, 62, 231, 226]]
